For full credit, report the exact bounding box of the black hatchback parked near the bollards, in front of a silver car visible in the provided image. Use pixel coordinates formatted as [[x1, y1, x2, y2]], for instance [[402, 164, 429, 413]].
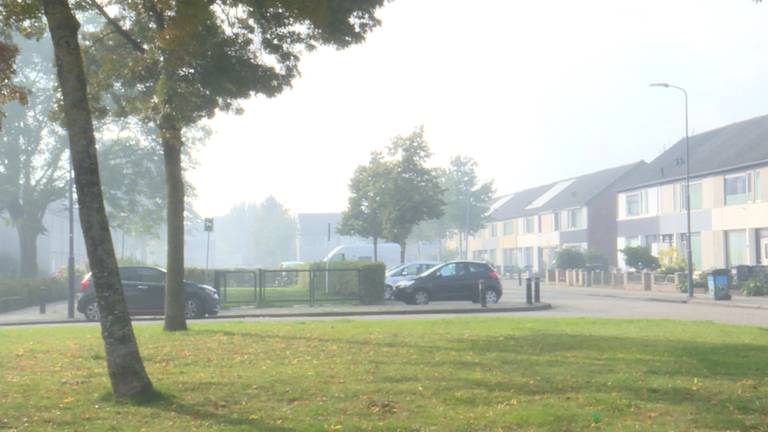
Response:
[[395, 261, 502, 305]]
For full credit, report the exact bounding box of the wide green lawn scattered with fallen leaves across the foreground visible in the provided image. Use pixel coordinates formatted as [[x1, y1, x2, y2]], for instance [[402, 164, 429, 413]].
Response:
[[0, 318, 768, 431]]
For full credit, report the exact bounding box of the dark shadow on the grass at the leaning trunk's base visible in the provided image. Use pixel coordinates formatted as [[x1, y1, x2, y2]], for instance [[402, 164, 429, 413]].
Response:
[[100, 390, 295, 432]]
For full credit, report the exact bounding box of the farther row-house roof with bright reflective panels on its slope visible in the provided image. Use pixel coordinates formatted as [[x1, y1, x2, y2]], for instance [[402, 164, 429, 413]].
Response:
[[491, 161, 645, 221]]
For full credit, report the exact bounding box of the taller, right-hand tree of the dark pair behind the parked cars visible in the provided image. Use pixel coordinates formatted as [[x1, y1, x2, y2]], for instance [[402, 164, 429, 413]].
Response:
[[383, 127, 445, 262]]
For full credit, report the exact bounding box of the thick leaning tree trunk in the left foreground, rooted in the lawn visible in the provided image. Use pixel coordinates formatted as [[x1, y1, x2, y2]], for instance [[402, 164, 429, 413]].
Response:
[[43, 0, 154, 398]]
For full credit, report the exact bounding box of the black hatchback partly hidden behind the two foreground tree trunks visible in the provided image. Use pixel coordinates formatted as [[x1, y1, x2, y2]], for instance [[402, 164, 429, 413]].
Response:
[[77, 266, 219, 321]]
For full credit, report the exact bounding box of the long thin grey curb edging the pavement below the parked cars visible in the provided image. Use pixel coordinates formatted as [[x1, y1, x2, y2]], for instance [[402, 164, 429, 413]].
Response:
[[0, 303, 552, 327]]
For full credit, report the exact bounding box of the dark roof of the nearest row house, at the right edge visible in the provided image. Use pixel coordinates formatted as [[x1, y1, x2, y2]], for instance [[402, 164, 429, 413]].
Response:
[[618, 115, 768, 191]]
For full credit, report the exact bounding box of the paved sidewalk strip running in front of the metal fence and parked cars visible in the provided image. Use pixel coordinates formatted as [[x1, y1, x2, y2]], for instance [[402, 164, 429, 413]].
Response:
[[0, 297, 552, 326]]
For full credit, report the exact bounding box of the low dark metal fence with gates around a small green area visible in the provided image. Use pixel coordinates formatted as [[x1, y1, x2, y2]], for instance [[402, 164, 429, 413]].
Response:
[[214, 269, 361, 307]]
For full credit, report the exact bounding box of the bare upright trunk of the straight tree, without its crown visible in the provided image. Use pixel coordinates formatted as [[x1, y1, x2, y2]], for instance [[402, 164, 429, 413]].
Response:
[[160, 111, 187, 331]]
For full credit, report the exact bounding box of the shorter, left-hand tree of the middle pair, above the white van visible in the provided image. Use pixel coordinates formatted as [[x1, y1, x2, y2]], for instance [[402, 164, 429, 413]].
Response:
[[337, 152, 392, 261]]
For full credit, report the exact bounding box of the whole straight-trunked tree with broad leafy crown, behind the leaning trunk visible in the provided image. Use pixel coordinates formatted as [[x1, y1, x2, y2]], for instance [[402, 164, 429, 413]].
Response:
[[84, 0, 385, 330]]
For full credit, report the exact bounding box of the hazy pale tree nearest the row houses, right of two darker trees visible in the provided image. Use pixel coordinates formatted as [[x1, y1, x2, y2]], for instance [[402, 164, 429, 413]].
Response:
[[441, 156, 496, 251]]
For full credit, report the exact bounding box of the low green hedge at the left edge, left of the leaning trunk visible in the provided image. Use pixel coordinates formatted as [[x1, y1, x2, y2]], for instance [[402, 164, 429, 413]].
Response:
[[0, 277, 69, 312]]
